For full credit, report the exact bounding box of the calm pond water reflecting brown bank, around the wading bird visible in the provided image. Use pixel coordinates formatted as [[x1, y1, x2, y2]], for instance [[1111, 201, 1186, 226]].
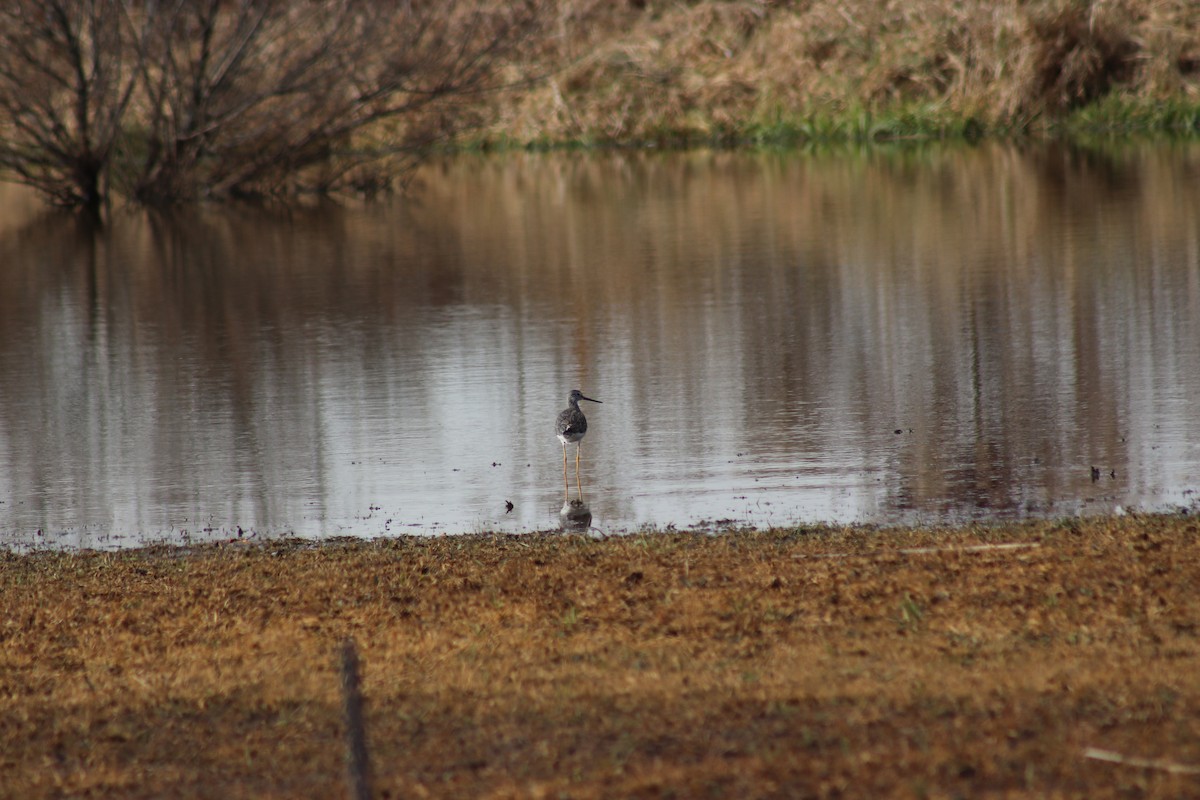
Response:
[[0, 144, 1200, 548]]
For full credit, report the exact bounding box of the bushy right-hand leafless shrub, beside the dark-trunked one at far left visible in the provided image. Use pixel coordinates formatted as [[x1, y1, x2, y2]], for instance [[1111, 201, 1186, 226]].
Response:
[[132, 0, 535, 201]]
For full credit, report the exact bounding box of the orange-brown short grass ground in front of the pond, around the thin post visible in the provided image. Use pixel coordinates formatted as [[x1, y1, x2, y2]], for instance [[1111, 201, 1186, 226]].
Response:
[[0, 516, 1200, 799]]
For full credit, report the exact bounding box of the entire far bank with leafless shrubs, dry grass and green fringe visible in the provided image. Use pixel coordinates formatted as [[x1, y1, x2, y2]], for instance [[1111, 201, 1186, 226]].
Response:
[[0, 0, 1200, 215]]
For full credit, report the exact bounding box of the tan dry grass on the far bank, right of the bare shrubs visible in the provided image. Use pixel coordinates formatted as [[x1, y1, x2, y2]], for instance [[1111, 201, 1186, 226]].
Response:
[[484, 0, 1200, 140]]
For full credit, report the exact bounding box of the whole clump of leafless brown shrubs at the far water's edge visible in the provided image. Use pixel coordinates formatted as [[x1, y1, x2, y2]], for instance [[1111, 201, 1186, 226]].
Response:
[[0, 0, 540, 206]]
